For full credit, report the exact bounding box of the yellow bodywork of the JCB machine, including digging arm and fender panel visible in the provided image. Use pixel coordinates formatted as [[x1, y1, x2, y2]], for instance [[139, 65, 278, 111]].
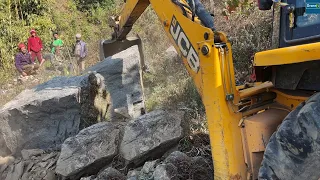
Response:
[[101, 0, 320, 180]]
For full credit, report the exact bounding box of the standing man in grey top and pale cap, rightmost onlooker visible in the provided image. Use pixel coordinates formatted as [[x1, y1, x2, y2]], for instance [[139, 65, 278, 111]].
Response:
[[74, 34, 88, 73]]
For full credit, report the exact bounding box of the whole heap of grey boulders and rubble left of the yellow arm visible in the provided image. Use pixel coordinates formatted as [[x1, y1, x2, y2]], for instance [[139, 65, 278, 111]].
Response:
[[0, 47, 213, 180]]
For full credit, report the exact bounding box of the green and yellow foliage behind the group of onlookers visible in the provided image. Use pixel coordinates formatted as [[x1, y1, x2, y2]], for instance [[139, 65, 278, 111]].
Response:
[[0, 0, 117, 84]]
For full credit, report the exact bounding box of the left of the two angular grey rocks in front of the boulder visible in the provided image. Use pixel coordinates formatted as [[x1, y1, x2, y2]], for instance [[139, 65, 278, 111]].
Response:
[[56, 122, 120, 179]]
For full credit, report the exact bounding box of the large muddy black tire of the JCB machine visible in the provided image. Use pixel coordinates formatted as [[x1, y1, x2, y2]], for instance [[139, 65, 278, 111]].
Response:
[[259, 93, 320, 180]]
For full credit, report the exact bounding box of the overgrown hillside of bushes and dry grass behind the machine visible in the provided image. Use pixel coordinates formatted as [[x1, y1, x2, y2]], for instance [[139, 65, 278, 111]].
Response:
[[0, 0, 272, 112]]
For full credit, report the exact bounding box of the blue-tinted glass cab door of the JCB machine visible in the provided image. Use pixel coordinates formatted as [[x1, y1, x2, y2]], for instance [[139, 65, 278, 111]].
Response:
[[279, 0, 320, 47]]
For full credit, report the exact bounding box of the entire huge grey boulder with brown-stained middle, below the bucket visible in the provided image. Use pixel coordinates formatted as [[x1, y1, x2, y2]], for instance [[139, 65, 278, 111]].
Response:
[[0, 46, 144, 156]]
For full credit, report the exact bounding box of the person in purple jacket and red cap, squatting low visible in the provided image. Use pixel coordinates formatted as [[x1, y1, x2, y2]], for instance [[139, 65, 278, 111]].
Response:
[[15, 43, 39, 76]]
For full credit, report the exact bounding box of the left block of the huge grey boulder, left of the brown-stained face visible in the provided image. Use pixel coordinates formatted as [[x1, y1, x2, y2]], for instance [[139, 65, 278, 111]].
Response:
[[0, 76, 86, 156]]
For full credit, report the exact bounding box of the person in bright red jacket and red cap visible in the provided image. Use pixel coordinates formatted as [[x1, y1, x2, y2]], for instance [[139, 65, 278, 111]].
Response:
[[28, 29, 44, 66]]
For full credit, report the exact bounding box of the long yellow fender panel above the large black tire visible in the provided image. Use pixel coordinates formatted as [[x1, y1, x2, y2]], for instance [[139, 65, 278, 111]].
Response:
[[254, 43, 320, 66]]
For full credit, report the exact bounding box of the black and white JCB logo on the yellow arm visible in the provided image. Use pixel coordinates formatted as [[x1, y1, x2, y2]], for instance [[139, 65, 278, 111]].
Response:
[[170, 16, 200, 73]]
